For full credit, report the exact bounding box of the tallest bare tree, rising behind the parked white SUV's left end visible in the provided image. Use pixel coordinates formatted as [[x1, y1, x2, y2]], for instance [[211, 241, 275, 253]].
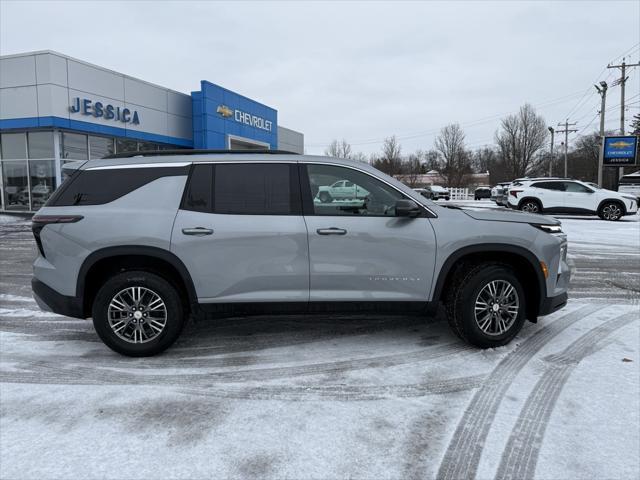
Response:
[[496, 103, 548, 177]]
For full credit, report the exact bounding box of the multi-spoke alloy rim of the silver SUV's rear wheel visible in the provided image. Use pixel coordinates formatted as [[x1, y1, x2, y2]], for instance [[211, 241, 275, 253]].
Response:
[[108, 287, 167, 343]]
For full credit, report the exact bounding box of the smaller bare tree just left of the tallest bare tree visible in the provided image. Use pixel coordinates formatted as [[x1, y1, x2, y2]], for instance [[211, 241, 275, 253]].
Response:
[[435, 123, 471, 187]]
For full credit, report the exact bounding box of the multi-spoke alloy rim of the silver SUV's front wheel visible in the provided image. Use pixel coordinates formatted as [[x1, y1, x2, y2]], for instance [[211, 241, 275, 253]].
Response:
[[474, 280, 520, 336]]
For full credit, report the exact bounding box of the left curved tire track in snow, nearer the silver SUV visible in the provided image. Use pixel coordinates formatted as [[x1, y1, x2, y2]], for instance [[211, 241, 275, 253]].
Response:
[[430, 304, 606, 480]]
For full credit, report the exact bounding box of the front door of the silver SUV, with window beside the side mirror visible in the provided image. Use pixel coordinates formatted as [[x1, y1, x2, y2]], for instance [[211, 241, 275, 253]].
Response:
[[301, 163, 436, 301]]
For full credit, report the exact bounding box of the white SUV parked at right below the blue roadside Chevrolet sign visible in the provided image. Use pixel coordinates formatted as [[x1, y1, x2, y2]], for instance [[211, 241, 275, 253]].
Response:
[[507, 179, 638, 220]]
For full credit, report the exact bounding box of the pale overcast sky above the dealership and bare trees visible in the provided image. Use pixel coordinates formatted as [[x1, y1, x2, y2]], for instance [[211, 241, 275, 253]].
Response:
[[0, 0, 640, 153]]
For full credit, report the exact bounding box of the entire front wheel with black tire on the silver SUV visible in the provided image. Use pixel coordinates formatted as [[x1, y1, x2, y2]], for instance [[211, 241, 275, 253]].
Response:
[[445, 262, 526, 348]]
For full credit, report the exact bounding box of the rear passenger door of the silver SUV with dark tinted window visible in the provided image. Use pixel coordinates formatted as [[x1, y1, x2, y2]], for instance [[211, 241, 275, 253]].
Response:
[[171, 162, 309, 303]]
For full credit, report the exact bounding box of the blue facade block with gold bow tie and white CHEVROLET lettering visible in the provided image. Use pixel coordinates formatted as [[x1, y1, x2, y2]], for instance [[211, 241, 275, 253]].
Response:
[[191, 80, 278, 149]]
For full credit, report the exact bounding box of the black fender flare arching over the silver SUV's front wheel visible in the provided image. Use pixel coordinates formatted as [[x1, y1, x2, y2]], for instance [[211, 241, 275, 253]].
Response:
[[432, 243, 547, 308]]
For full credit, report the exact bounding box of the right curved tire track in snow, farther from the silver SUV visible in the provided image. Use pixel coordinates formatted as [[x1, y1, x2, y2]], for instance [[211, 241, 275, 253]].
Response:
[[496, 313, 638, 479]]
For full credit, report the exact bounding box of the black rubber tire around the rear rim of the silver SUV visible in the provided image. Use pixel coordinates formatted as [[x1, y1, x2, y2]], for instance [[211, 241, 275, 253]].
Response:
[[92, 271, 187, 357]]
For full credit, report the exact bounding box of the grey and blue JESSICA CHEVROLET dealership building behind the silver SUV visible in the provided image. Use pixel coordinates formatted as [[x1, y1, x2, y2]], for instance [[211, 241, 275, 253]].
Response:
[[0, 51, 304, 212]]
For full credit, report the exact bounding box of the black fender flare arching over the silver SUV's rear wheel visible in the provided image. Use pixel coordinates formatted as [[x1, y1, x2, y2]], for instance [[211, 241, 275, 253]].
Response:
[[76, 245, 198, 304]]
